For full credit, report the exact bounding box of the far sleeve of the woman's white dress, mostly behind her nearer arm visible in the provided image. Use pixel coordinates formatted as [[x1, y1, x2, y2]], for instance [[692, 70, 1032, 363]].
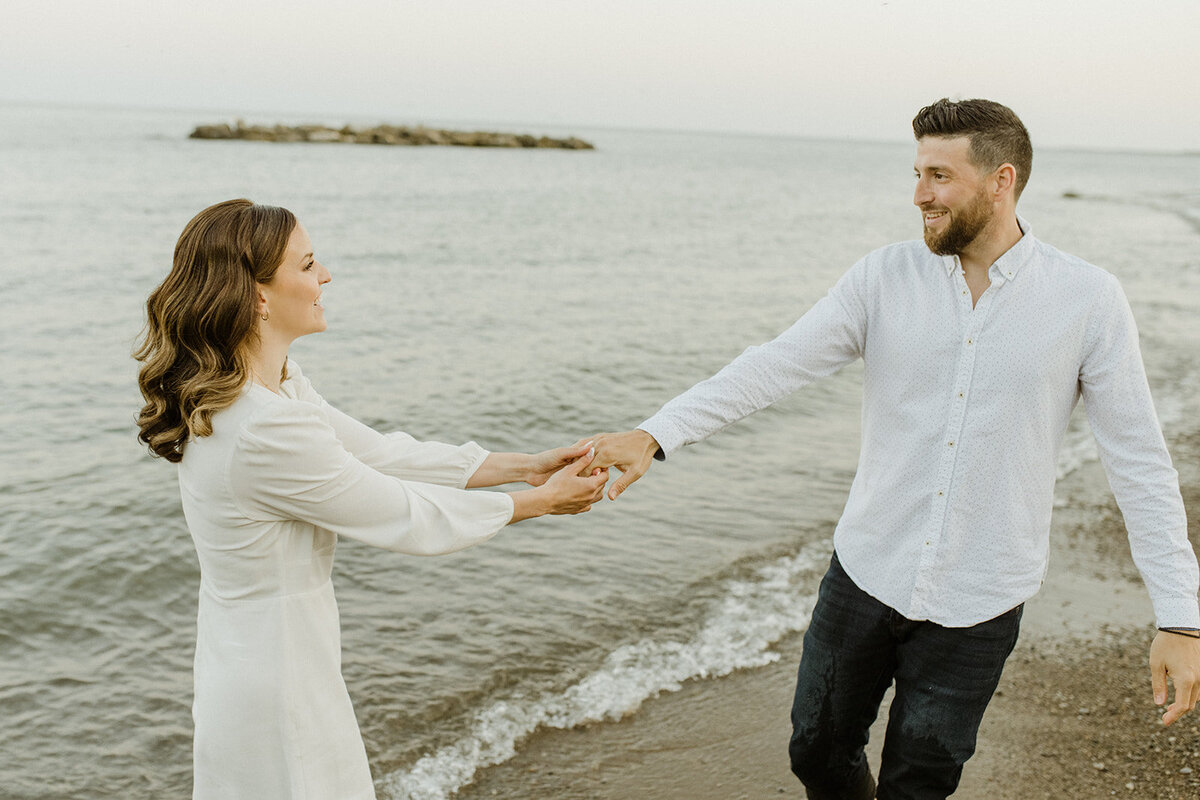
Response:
[[280, 360, 488, 489]]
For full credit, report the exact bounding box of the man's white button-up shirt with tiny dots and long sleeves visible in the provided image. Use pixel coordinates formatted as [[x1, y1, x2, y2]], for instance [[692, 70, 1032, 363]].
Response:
[[638, 219, 1200, 627]]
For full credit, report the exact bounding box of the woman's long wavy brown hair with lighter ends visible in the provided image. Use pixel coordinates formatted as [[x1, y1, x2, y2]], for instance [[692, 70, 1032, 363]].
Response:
[[133, 199, 296, 462]]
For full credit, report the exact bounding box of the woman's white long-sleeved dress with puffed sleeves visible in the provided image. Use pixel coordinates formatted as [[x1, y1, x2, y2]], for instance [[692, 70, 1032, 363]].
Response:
[[179, 362, 512, 800]]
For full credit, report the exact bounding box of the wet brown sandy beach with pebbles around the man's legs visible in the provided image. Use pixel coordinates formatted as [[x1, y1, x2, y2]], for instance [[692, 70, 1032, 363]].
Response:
[[457, 435, 1200, 800]]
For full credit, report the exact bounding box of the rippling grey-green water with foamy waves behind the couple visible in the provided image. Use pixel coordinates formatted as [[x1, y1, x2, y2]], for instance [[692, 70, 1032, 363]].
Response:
[[0, 106, 1200, 800]]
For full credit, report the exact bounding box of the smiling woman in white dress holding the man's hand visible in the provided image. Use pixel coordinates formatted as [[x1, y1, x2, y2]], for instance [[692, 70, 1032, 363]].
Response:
[[134, 200, 606, 800]]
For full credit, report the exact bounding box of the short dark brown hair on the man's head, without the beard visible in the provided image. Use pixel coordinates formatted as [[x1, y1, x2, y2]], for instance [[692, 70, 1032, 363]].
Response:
[[912, 97, 1033, 197]]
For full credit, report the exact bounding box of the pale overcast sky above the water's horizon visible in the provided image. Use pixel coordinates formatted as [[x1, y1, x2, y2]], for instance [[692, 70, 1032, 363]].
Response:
[[0, 0, 1200, 150]]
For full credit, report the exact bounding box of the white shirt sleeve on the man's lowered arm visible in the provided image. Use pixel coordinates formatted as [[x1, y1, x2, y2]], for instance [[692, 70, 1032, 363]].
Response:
[[1079, 278, 1200, 627]]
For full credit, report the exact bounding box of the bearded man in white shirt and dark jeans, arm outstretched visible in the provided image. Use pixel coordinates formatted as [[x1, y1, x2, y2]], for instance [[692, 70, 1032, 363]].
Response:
[[592, 100, 1200, 800]]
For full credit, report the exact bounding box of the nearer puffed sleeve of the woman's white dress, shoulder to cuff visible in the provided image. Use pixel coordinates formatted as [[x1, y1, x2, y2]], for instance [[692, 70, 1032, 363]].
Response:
[[228, 399, 512, 555]]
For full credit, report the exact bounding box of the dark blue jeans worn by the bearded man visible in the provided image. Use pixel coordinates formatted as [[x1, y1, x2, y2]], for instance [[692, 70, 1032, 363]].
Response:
[[788, 554, 1022, 800]]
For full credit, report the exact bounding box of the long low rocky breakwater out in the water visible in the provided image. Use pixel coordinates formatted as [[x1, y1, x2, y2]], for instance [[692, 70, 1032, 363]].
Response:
[[188, 120, 595, 150]]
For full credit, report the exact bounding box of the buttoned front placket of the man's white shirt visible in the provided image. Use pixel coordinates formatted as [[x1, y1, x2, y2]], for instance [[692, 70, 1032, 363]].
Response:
[[910, 258, 1003, 619]]
